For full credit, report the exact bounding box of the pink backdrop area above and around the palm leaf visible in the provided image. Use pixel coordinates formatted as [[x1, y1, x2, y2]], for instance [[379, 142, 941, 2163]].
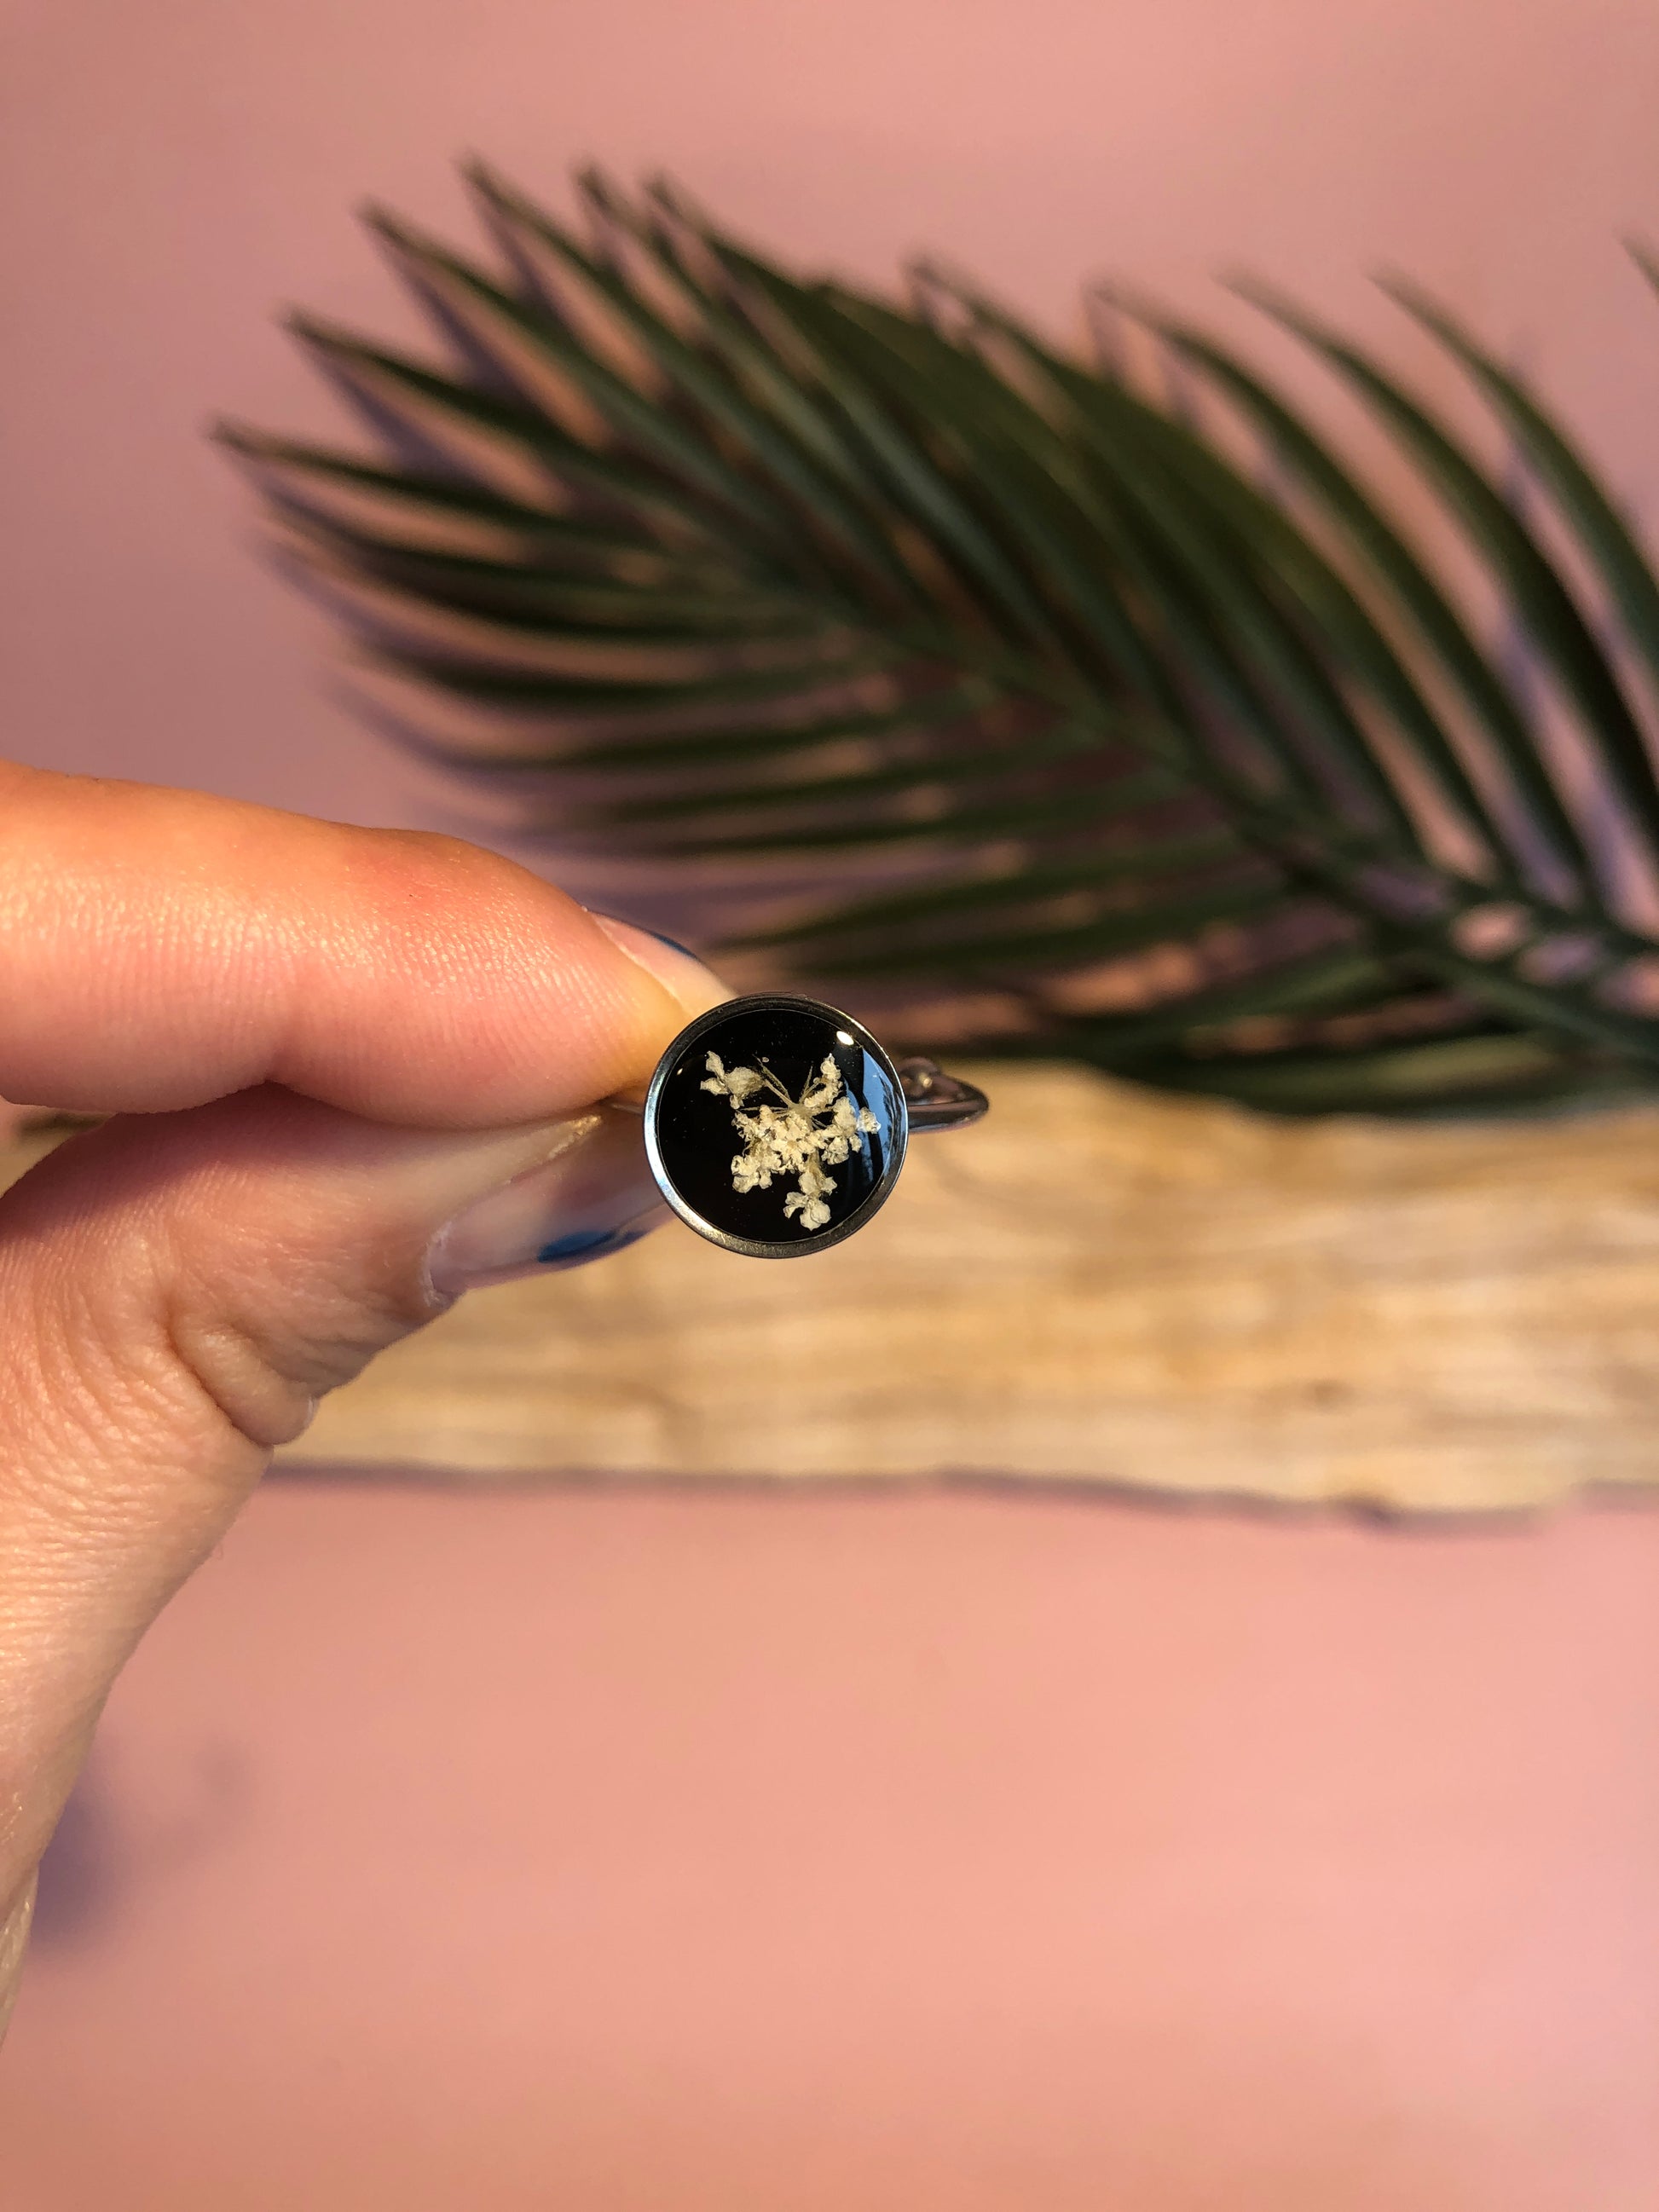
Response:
[[0, 0, 1659, 818]]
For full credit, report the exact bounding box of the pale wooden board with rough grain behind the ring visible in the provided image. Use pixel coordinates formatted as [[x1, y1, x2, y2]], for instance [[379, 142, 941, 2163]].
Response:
[[14, 1068, 1659, 1510]]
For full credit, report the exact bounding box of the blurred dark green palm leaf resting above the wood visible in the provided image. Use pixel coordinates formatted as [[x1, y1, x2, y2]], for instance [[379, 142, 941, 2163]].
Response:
[[211, 168, 1659, 1111]]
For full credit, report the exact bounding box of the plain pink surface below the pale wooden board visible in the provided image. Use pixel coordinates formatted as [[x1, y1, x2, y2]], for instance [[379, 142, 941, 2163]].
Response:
[[0, 1484, 1659, 2212]]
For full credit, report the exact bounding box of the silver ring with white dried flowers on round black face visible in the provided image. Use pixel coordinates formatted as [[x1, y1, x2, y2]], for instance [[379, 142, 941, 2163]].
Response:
[[646, 993, 989, 1259]]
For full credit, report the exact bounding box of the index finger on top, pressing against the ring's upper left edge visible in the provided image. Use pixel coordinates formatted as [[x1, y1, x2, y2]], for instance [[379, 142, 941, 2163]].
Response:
[[0, 763, 695, 1128]]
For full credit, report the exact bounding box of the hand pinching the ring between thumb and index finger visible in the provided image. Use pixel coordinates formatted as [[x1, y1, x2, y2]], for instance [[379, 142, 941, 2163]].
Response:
[[0, 763, 725, 2029]]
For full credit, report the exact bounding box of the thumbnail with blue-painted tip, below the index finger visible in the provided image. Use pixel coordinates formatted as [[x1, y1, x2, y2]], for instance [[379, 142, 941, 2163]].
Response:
[[427, 1106, 668, 1298]]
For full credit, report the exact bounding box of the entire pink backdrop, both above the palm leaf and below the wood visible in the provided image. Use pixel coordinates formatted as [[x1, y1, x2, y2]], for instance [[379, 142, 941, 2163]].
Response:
[[0, 0, 1659, 2212]]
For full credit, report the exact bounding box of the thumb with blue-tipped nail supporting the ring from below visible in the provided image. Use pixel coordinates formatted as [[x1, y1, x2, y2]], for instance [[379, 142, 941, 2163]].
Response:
[[0, 989, 717, 2019]]
